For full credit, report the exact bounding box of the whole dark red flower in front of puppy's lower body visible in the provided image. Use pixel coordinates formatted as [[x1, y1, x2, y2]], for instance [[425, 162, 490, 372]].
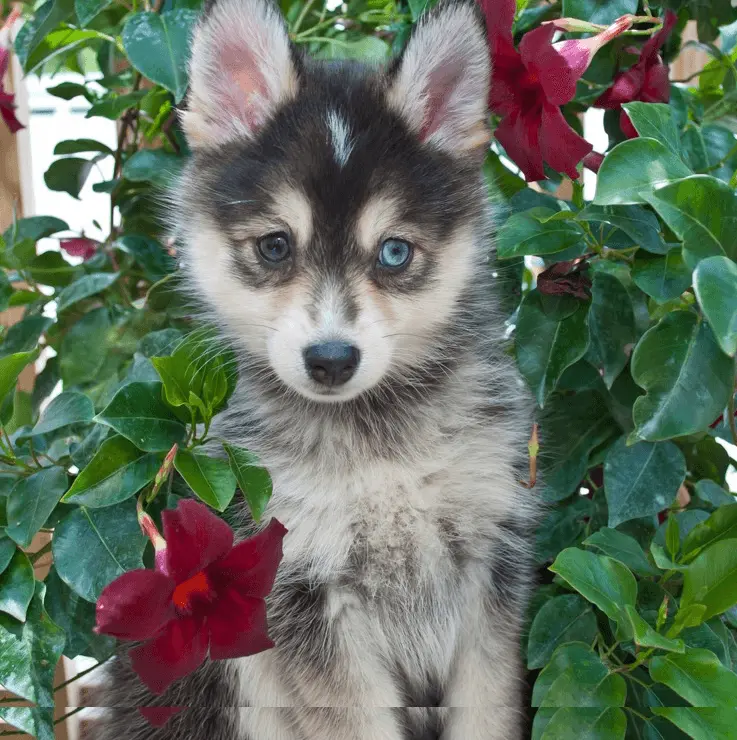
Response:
[[95, 500, 287, 694]]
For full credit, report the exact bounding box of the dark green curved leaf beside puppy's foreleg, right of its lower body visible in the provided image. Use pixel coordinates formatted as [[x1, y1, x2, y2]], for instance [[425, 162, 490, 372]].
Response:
[[527, 594, 599, 669]]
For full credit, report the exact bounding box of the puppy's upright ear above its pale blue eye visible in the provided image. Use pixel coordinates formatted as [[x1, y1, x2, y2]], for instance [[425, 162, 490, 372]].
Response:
[[388, 0, 490, 156]]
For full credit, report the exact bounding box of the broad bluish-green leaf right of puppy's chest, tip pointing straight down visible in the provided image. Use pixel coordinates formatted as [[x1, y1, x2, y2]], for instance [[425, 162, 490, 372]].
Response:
[[604, 437, 686, 527]]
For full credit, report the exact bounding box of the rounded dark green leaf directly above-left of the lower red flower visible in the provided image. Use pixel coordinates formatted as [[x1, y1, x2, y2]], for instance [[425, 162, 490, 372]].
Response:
[[52, 502, 146, 602]]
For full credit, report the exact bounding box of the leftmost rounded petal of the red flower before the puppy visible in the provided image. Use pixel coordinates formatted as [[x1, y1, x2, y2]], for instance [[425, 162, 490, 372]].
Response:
[[95, 570, 174, 640]]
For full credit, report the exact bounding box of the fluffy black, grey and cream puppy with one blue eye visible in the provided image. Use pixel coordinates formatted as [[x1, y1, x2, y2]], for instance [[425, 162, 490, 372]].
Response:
[[103, 0, 534, 740]]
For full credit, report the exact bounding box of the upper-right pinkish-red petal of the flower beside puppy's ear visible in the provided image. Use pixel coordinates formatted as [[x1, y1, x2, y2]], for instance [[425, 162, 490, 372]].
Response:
[[519, 25, 583, 105]]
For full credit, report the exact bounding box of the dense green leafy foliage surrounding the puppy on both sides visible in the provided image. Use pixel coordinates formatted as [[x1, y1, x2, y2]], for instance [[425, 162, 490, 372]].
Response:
[[0, 0, 737, 740]]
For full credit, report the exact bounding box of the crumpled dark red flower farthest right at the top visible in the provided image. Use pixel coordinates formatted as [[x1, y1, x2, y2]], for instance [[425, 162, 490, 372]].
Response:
[[594, 10, 678, 139]]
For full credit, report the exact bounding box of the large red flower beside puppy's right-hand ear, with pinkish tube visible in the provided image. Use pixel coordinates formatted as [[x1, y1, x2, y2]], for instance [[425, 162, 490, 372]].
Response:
[[479, 0, 632, 181]]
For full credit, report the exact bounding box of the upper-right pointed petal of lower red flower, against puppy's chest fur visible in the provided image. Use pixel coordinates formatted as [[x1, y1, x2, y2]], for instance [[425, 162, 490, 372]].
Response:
[[208, 519, 287, 598]]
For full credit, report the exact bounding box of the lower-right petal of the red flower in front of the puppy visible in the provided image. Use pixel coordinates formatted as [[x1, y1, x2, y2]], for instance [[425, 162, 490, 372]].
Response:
[[207, 589, 274, 660]]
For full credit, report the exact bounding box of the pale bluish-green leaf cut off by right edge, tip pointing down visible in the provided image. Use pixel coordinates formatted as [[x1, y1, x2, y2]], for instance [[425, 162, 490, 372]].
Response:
[[693, 257, 737, 356]]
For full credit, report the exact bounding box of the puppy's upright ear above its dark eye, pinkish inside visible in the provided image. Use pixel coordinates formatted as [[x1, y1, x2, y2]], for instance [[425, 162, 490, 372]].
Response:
[[182, 0, 298, 149]]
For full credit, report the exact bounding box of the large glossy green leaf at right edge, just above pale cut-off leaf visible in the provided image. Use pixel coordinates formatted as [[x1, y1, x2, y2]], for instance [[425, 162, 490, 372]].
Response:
[[647, 175, 737, 269]]
